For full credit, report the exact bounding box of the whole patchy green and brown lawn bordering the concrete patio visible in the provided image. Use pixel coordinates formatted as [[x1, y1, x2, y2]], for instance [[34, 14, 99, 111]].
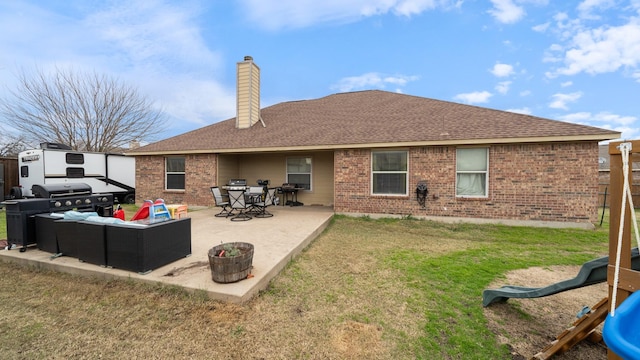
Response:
[[0, 208, 632, 359]]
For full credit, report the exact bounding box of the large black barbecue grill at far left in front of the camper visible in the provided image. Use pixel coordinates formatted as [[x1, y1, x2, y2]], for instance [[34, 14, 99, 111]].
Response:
[[3, 183, 113, 251]]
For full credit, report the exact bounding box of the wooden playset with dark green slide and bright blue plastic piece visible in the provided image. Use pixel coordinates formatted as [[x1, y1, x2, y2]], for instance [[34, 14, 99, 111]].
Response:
[[483, 140, 640, 360]]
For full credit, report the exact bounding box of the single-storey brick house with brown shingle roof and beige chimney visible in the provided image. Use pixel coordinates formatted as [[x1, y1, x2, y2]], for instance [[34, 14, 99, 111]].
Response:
[[128, 57, 621, 224]]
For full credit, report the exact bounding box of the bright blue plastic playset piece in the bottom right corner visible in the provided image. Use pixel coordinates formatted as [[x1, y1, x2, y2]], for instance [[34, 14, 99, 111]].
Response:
[[602, 291, 640, 360]]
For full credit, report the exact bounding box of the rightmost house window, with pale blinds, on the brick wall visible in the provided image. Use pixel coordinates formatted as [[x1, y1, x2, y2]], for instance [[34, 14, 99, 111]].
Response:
[[456, 148, 489, 197]]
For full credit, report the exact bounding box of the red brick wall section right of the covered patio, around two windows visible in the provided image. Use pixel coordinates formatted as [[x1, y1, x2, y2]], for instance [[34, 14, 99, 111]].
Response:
[[334, 142, 598, 222]]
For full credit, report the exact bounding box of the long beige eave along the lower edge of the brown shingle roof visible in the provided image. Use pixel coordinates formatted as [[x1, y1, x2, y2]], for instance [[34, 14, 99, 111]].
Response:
[[126, 133, 622, 156]]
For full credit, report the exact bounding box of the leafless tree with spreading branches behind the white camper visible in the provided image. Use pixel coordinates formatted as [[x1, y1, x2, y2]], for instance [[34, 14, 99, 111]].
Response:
[[0, 69, 166, 152]]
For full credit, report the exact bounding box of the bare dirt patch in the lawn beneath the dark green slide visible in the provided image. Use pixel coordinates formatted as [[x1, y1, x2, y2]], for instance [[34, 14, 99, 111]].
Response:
[[485, 266, 608, 360]]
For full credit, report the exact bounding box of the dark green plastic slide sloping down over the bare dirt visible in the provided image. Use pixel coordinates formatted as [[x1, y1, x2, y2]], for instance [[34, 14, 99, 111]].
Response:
[[482, 248, 640, 306]]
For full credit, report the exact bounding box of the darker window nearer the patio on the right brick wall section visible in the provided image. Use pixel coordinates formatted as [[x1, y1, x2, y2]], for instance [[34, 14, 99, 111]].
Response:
[[371, 150, 409, 195]]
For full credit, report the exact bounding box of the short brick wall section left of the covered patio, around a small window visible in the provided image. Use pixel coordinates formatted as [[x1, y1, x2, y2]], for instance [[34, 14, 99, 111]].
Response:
[[136, 154, 217, 206]]
